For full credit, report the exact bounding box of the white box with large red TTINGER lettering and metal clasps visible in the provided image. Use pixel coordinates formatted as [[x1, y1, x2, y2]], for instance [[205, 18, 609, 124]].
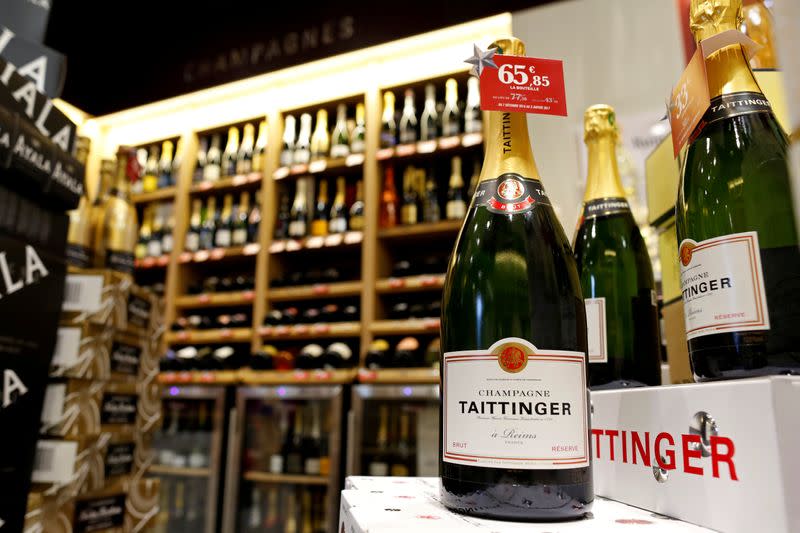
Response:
[[591, 377, 800, 533]]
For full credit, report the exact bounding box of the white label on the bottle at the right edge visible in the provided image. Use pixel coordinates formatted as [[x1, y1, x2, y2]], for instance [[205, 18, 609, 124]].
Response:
[[679, 231, 769, 339]]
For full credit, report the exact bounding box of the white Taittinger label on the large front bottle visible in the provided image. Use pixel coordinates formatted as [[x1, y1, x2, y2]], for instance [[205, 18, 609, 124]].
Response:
[[442, 337, 589, 470]]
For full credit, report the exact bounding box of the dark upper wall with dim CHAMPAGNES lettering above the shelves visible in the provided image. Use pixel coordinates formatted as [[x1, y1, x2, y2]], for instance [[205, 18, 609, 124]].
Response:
[[46, 0, 553, 115]]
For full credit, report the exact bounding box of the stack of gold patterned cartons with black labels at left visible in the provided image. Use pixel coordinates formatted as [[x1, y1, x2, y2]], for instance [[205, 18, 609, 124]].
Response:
[[26, 267, 163, 533]]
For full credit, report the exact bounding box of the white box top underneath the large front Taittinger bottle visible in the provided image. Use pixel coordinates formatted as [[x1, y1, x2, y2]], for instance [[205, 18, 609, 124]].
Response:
[[338, 477, 708, 533]]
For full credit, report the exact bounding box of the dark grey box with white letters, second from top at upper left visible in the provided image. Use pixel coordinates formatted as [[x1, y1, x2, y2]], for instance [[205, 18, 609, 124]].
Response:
[[0, 25, 67, 98]]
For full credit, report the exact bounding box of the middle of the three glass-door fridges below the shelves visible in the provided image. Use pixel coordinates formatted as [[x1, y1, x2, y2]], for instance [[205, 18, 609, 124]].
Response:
[[222, 385, 343, 533]]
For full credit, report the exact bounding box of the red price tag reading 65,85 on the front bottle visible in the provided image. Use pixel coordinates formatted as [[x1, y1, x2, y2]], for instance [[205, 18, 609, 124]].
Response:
[[481, 55, 567, 117]]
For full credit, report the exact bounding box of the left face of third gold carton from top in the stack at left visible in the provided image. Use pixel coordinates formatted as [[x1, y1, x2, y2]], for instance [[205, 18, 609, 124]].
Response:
[[41, 379, 105, 439]]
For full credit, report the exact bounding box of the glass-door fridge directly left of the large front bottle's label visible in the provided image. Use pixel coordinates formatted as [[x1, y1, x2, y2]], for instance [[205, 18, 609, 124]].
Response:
[[347, 385, 439, 476]]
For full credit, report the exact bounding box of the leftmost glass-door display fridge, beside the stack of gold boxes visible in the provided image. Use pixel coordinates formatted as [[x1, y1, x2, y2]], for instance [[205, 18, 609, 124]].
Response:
[[150, 385, 225, 533]]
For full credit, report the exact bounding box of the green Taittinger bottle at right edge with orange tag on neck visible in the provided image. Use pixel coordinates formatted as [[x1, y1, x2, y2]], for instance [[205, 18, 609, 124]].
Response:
[[675, 0, 800, 381]]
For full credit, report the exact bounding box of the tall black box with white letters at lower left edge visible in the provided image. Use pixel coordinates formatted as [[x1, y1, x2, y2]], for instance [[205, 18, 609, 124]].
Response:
[[0, 235, 66, 531]]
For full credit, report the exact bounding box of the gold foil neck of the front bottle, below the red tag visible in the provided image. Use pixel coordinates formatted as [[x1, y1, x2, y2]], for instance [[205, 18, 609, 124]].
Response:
[[481, 111, 540, 180]]
